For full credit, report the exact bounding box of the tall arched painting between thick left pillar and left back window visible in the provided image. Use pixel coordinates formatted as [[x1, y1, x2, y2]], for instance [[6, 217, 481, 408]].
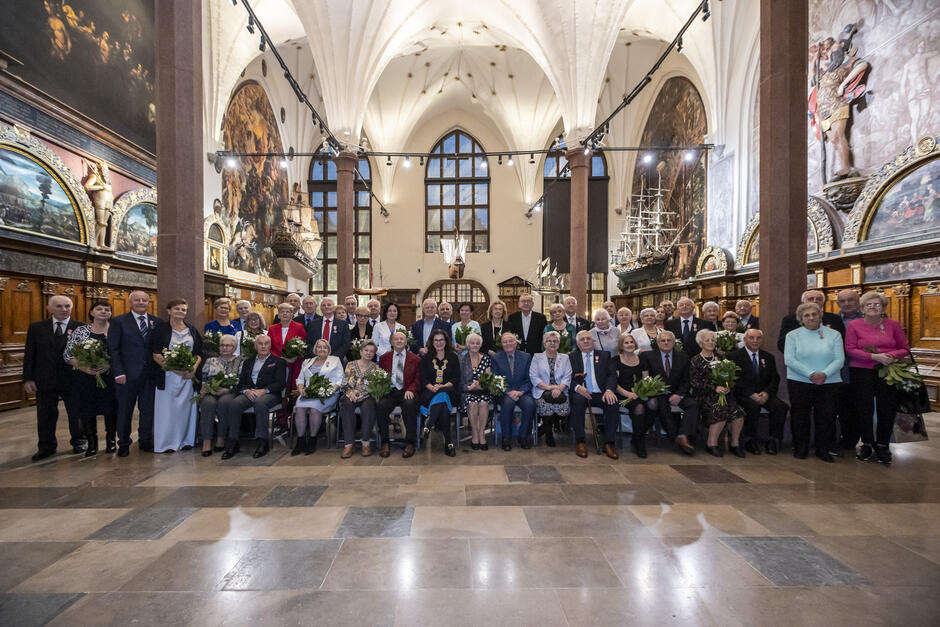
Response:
[[221, 83, 288, 280]]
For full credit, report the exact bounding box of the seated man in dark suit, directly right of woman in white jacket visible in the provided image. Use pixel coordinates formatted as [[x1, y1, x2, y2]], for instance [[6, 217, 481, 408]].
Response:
[[568, 331, 620, 459]]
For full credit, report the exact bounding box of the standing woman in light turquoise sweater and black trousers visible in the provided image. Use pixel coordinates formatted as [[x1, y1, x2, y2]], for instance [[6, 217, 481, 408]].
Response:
[[784, 302, 845, 463]]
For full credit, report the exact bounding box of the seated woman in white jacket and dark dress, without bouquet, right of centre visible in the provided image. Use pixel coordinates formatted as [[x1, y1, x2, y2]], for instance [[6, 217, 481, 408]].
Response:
[[529, 332, 572, 446]]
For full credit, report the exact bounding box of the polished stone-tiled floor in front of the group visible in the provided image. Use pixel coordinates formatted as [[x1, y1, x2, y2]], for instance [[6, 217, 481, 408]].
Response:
[[0, 409, 940, 627]]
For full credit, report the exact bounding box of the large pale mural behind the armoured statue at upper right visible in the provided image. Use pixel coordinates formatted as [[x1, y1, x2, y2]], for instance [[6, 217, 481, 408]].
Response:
[[807, 0, 940, 192]]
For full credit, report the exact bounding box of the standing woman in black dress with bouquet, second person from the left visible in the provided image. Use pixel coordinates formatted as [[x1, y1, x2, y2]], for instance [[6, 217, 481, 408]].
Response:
[[62, 300, 117, 457]]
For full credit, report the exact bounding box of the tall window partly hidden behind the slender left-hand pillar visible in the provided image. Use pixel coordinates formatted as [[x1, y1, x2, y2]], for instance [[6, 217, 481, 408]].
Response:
[[308, 156, 372, 298]]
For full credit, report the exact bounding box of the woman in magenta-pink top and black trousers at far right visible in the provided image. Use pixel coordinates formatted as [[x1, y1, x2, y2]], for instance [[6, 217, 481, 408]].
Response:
[[845, 292, 911, 464]]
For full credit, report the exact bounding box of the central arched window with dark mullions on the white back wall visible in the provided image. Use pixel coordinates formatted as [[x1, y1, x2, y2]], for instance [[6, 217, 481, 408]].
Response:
[[424, 131, 490, 253]]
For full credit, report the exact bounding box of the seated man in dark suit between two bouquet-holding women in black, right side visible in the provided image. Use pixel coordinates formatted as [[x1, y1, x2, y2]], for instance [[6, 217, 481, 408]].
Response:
[[640, 330, 698, 455]]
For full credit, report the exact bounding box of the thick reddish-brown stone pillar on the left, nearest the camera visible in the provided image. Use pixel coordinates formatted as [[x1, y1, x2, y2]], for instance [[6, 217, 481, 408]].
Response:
[[155, 0, 205, 328]]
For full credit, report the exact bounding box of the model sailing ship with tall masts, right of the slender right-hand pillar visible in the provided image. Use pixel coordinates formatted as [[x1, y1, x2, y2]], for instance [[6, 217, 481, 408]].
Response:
[[610, 162, 681, 285]]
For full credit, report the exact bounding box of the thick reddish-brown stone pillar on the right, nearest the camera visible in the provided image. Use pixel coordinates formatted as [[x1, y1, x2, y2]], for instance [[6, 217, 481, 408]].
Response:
[[759, 0, 809, 358]]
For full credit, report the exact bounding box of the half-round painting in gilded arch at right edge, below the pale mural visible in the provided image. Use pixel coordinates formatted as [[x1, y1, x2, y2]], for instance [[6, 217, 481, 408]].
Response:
[[865, 158, 940, 240]]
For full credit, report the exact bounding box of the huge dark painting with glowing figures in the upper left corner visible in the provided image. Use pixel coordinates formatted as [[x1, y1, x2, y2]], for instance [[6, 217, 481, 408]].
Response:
[[0, 0, 156, 152]]
